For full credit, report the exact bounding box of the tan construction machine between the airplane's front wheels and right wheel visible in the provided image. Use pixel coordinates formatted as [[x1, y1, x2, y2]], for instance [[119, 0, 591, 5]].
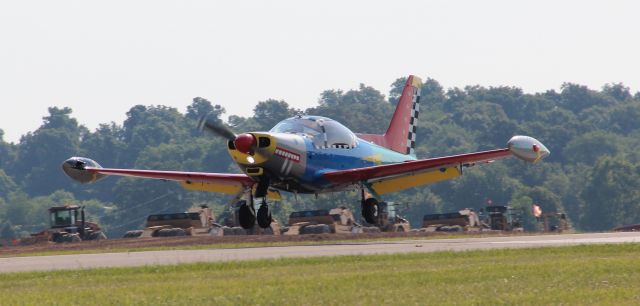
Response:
[[284, 207, 360, 235]]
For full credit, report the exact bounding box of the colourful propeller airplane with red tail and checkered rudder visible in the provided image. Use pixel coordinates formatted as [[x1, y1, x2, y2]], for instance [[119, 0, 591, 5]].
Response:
[[62, 75, 550, 229]]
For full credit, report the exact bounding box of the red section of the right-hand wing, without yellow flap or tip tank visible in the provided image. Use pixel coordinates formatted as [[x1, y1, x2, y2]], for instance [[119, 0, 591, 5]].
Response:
[[323, 149, 512, 184]]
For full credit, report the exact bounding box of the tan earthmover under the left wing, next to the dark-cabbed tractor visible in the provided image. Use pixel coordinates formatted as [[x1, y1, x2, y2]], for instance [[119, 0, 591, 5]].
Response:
[[123, 205, 214, 238]]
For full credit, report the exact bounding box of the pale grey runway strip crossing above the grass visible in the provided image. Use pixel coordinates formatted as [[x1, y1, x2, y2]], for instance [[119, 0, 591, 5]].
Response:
[[0, 232, 640, 273]]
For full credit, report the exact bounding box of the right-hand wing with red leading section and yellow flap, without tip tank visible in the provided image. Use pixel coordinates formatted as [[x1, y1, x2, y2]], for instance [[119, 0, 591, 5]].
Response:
[[323, 148, 512, 194]]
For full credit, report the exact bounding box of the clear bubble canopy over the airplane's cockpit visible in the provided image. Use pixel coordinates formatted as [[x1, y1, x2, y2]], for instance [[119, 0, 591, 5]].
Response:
[[270, 116, 356, 149]]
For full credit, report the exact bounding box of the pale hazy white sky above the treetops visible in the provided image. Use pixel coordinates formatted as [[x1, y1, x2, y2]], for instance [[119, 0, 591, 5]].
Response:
[[0, 0, 640, 142]]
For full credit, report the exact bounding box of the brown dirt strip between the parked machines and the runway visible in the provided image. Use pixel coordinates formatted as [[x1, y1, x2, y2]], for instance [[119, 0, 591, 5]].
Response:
[[0, 232, 504, 257]]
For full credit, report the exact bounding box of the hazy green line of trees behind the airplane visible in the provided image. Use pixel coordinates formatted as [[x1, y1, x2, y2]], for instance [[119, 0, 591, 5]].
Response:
[[0, 78, 640, 238]]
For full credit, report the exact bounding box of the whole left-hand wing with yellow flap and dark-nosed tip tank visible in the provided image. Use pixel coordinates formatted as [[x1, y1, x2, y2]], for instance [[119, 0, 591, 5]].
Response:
[[62, 157, 255, 194]]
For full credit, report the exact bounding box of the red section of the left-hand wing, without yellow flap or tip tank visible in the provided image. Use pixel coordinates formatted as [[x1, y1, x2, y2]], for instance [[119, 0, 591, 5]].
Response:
[[85, 167, 255, 187]]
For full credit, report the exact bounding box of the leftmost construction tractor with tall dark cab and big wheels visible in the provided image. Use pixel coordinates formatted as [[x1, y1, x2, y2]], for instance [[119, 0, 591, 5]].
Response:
[[20, 205, 107, 244]]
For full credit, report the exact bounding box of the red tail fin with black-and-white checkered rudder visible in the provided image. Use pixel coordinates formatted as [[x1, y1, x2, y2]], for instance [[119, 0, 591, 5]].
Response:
[[358, 75, 422, 156]]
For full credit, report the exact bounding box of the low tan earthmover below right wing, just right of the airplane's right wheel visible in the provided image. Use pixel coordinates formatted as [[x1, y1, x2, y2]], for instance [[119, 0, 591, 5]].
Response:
[[422, 208, 481, 232]]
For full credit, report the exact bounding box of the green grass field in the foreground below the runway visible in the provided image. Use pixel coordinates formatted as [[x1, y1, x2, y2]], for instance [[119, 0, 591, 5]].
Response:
[[0, 244, 640, 305]]
